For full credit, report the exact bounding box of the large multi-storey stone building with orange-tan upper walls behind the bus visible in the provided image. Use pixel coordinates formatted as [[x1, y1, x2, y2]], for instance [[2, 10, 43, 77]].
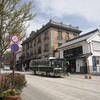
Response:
[[22, 20, 81, 66]]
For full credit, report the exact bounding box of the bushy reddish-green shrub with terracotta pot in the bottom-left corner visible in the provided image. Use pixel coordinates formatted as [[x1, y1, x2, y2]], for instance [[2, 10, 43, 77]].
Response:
[[0, 73, 27, 100]]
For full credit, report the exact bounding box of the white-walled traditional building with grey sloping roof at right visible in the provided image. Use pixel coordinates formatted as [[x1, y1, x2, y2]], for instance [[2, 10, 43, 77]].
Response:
[[58, 29, 100, 73]]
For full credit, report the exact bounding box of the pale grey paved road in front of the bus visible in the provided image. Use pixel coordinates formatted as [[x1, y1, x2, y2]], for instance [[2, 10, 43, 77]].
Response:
[[22, 73, 100, 100]]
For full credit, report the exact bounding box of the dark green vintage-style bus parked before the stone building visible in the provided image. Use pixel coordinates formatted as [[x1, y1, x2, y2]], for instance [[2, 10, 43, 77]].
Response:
[[29, 57, 68, 76]]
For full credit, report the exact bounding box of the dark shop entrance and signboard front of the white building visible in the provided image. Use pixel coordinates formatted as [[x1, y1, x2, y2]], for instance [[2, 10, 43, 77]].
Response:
[[63, 46, 87, 73]]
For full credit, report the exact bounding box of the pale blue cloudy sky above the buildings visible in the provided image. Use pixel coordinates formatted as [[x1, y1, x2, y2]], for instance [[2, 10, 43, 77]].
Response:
[[24, 0, 100, 36]]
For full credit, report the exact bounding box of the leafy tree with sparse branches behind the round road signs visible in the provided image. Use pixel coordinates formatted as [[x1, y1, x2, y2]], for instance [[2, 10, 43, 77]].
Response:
[[0, 0, 35, 69]]
